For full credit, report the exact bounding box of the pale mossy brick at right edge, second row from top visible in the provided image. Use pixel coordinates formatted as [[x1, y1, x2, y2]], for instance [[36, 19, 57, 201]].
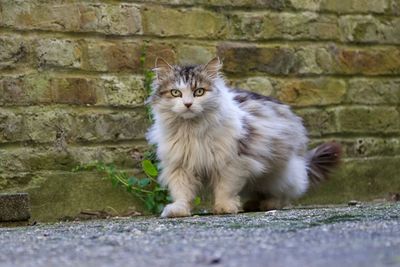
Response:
[[339, 15, 400, 44]]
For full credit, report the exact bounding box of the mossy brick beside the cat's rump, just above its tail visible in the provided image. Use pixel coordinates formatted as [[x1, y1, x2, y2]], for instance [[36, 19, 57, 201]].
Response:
[[296, 108, 338, 137]]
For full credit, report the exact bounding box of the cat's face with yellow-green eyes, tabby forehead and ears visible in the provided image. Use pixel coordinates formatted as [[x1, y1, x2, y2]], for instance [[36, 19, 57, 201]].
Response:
[[151, 59, 221, 119]]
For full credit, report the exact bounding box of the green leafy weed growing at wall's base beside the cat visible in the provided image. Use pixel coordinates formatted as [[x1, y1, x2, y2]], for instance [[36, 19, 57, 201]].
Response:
[[73, 160, 171, 214]]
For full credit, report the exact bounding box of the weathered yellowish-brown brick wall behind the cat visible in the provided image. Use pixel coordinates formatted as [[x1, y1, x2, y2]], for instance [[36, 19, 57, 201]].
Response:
[[0, 0, 400, 219]]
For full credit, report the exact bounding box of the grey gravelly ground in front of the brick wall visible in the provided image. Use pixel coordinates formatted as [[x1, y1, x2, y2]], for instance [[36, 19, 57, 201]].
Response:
[[0, 203, 400, 267]]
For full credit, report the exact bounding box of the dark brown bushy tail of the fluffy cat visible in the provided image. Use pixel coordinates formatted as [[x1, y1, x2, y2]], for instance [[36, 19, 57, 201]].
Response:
[[306, 142, 342, 185]]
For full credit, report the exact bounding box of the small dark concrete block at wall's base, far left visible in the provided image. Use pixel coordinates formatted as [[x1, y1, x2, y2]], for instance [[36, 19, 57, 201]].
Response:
[[0, 193, 31, 222]]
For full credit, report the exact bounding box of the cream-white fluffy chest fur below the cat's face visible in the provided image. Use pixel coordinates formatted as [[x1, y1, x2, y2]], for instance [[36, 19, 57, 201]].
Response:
[[149, 112, 240, 178]]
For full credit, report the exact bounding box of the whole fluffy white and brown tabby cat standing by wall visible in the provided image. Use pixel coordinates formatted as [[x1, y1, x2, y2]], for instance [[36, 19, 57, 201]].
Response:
[[147, 58, 340, 217]]
